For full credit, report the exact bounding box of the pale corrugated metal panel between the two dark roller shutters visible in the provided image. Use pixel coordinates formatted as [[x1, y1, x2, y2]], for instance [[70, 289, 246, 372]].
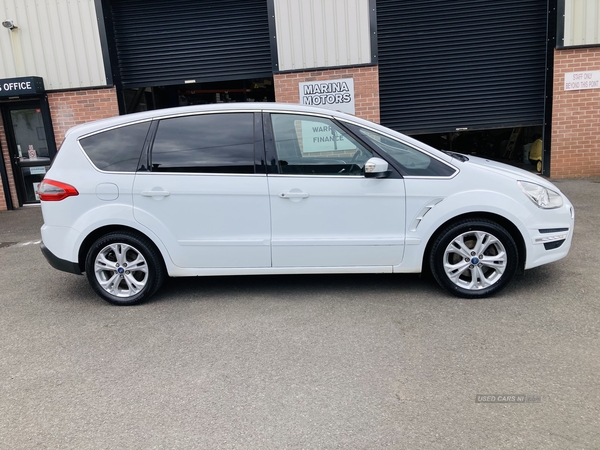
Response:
[[275, 0, 371, 70]]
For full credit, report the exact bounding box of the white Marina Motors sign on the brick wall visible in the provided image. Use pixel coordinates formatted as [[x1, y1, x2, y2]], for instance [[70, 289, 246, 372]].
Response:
[[298, 78, 354, 114]]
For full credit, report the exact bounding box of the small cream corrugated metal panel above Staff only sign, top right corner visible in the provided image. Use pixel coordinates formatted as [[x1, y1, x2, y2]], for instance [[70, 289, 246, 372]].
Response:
[[558, 0, 600, 47]]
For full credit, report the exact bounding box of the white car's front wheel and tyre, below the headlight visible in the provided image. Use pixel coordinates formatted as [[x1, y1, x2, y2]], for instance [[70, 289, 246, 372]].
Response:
[[429, 219, 519, 298]]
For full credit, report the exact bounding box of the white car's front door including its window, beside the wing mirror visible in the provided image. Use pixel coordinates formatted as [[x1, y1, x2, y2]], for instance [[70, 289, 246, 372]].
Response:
[[265, 113, 405, 270]]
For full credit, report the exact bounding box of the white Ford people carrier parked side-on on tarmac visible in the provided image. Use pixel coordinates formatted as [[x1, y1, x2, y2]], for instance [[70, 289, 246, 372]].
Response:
[[39, 103, 574, 305]]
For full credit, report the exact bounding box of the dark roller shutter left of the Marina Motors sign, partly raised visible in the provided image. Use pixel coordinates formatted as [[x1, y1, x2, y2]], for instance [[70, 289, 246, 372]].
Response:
[[110, 0, 273, 88]]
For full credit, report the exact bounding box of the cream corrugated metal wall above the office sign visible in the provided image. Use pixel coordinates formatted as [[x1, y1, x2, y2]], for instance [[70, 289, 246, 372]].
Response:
[[0, 0, 106, 90]]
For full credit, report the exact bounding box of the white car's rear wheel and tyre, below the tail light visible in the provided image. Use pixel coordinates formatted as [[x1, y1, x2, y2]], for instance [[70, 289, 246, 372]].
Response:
[[85, 231, 166, 305]]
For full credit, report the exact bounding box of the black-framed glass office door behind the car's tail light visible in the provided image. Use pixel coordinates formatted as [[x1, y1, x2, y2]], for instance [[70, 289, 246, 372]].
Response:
[[3, 101, 53, 205]]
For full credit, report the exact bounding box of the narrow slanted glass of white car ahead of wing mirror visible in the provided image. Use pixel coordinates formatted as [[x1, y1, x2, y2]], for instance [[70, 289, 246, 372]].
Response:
[[357, 127, 456, 177]]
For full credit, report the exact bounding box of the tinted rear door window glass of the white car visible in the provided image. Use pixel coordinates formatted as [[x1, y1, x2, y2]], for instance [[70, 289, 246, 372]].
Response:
[[151, 113, 254, 174]]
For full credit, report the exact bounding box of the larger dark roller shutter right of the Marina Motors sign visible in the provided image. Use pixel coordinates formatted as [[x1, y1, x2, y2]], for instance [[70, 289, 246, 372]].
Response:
[[377, 0, 548, 134]]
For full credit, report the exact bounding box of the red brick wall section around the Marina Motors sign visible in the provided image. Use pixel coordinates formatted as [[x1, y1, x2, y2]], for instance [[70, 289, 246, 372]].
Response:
[[274, 66, 379, 123]]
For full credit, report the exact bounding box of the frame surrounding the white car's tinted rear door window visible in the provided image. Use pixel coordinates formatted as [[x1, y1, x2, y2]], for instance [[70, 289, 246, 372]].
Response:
[[140, 109, 267, 176]]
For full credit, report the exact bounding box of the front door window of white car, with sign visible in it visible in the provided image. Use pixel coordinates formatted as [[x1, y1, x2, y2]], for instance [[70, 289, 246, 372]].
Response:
[[271, 114, 372, 176]]
